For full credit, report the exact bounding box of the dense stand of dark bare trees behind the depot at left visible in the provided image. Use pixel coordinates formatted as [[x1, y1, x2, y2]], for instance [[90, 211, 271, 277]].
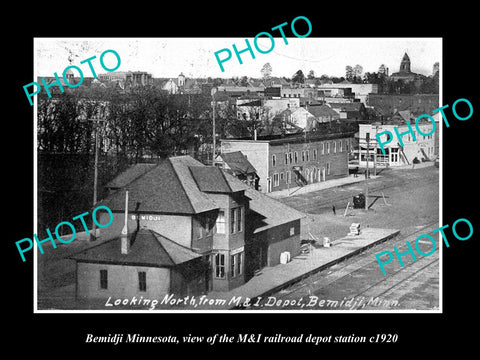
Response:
[[37, 86, 257, 231]]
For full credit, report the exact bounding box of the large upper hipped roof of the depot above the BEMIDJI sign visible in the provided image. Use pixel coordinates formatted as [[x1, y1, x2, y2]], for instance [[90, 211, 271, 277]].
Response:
[[99, 156, 248, 215]]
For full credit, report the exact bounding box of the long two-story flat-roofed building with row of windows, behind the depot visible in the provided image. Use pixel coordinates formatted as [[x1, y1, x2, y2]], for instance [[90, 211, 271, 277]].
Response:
[[221, 132, 354, 193]]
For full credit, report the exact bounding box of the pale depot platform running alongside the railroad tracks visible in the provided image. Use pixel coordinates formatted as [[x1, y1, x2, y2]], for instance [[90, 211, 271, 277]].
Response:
[[188, 228, 400, 310]]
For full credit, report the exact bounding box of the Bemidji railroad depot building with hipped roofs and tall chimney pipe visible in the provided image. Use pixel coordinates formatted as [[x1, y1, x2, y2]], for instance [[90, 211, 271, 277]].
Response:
[[72, 156, 302, 299]]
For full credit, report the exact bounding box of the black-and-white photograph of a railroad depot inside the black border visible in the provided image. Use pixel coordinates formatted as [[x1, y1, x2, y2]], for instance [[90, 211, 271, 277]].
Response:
[[32, 37, 438, 313]]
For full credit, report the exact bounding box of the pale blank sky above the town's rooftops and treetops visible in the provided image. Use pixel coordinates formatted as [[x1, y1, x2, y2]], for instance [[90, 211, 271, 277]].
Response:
[[34, 36, 442, 78]]
